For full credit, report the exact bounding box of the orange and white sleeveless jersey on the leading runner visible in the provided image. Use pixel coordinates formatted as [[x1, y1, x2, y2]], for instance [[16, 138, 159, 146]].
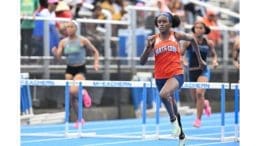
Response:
[[154, 32, 184, 79]]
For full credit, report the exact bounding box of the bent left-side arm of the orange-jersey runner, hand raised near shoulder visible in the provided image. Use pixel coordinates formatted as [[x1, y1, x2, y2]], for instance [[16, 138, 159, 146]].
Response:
[[140, 36, 155, 65]]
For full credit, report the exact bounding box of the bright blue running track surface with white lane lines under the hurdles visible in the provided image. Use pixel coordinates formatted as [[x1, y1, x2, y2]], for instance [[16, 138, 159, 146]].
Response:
[[21, 113, 239, 146]]
